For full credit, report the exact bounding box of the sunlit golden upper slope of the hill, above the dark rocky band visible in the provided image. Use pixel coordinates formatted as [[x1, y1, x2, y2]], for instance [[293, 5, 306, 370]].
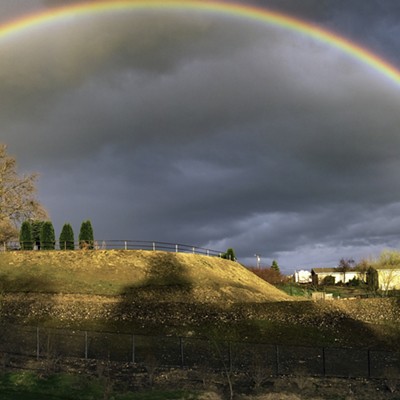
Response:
[[0, 250, 290, 303]]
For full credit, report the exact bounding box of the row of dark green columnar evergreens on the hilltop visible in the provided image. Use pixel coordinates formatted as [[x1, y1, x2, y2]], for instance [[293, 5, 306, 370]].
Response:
[[19, 220, 94, 250]]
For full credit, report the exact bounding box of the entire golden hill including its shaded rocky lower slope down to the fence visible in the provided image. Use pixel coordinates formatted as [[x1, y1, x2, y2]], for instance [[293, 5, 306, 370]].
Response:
[[0, 250, 400, 348]]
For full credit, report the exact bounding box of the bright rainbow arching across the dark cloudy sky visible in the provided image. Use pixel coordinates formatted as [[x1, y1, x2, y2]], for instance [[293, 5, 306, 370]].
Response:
[[0, 0, 400, 86]]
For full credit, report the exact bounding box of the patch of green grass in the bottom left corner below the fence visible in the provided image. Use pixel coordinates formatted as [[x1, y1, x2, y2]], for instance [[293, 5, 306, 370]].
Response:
[[0, 372, 197, 400]]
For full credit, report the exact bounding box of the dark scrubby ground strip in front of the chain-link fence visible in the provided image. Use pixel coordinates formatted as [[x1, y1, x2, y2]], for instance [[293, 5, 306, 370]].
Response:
[[0, 371, 400, 400]]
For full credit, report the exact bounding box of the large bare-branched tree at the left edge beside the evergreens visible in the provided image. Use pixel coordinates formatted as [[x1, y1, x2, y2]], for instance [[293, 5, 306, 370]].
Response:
[[0, 144, 47, 243]]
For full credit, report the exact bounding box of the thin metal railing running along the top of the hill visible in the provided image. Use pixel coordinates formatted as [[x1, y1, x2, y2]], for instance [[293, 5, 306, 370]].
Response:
[[1, 240, 224, 257]]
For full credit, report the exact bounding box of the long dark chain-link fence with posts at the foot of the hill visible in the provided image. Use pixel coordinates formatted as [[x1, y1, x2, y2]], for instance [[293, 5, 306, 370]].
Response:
[[0, 324, 400, 378]]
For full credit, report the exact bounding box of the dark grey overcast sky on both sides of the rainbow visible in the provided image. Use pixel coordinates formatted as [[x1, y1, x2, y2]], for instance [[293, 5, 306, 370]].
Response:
[[0, 0, 400, 273]]
